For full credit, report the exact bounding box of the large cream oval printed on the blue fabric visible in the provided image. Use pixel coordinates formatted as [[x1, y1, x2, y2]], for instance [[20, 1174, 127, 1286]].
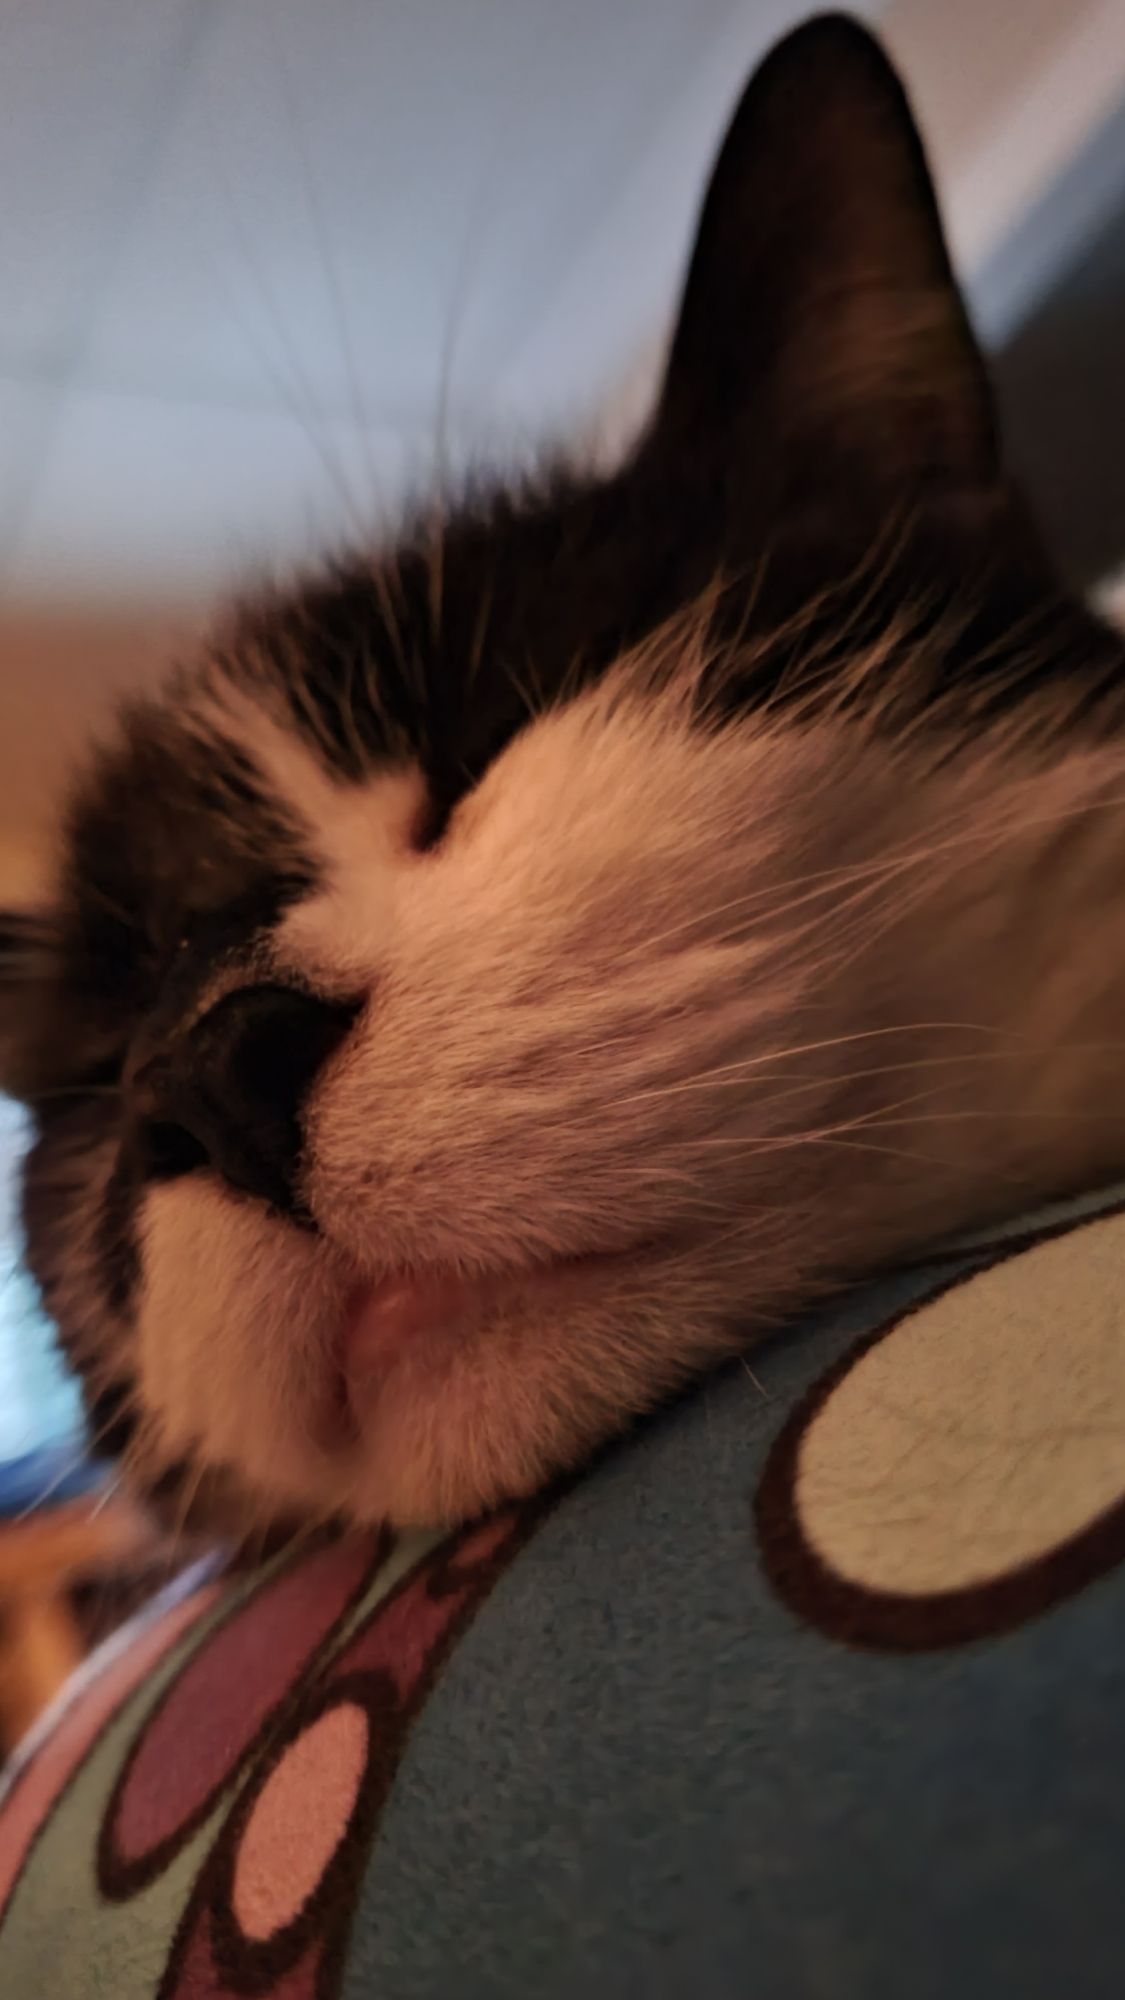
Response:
[[797, 1214, 1125, 1596]]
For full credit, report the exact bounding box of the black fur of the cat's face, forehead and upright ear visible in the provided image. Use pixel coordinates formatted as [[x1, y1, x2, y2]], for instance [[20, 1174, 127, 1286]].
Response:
[[0, 18, 1123, 1488]]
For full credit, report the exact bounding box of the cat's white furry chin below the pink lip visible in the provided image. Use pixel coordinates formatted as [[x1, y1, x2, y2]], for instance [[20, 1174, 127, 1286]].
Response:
[[300, 1244, 700, 1526]]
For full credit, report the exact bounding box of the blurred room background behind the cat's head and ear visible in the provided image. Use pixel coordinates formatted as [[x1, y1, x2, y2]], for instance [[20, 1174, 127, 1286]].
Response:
[[0, 0, 1125, 1752]]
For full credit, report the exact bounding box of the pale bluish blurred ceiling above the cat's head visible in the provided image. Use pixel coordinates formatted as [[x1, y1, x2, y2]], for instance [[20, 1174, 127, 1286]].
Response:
[[0, 0, 1125, 606]]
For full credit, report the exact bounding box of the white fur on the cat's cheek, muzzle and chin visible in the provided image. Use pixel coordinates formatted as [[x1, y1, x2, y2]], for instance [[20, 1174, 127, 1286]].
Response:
[[124, 656, 1125, 1522]]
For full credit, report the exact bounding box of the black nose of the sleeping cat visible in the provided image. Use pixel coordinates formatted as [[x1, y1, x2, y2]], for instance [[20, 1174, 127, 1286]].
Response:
[[128, 986, 356, 1214]]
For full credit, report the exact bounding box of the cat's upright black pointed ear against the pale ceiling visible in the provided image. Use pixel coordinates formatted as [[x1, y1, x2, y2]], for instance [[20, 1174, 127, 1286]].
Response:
[[657, 14, 997, 486]]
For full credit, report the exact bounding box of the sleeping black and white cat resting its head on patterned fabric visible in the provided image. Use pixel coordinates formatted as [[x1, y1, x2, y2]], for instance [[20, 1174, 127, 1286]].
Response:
[[0, 16, 1125, 1524]]
